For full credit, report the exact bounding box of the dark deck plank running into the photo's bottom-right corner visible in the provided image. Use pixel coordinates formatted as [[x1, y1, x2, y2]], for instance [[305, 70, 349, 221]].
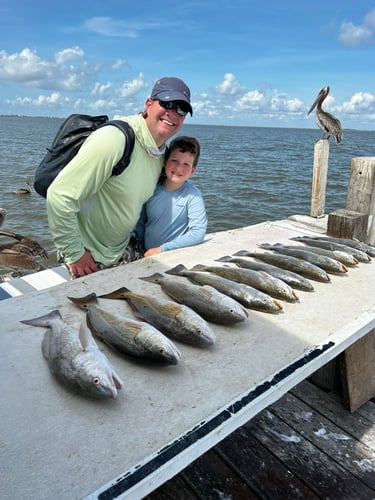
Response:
[[245, 410, 374, 500]]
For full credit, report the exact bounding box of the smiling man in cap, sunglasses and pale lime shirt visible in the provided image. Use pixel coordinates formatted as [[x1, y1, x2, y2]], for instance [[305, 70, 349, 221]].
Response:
[[47, 77, 193, 277]]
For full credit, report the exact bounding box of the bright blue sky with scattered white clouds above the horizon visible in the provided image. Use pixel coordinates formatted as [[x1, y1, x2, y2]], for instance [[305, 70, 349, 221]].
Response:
[[0, 0, 375, 130]]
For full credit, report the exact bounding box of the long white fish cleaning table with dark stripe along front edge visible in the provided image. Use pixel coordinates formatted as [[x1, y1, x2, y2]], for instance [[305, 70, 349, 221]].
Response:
[[0, 220, 375, 500]]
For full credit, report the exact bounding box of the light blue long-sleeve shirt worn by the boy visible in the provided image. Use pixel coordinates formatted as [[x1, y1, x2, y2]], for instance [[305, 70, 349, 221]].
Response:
[[135, 181, 207, 252]]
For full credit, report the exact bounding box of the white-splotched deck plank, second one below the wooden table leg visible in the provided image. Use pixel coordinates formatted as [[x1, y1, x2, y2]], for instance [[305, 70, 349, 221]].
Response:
[[270, 393, 375, 489]]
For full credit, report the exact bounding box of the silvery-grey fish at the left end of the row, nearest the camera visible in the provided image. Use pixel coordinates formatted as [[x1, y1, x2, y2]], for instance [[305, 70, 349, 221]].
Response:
[[21, 309, 123, 399]]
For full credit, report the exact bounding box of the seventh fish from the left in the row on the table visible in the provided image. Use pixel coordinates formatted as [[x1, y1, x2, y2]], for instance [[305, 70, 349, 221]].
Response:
[[217, 254, 314, 292]]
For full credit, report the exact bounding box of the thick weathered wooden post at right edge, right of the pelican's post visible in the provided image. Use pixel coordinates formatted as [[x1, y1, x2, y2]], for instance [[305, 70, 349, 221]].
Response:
[[346, 156, 375, 245]]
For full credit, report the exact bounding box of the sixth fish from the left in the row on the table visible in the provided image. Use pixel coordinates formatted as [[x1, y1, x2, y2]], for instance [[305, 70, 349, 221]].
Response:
[[192, 264, 299, 302]]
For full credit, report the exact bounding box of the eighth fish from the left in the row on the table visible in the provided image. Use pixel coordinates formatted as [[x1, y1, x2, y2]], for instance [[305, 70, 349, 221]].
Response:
[[237, 250, 331, 283]]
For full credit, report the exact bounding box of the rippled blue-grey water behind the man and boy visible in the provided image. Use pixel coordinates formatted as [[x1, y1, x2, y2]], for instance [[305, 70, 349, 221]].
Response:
[[0, 116, 375, 266]]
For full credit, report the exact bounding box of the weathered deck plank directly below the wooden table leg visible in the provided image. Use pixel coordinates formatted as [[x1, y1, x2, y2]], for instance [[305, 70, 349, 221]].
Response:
[[290, 381, 375, 453]]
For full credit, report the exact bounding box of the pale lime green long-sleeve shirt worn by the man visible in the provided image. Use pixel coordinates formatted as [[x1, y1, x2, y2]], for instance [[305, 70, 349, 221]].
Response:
[[47, 115, 164, 267]]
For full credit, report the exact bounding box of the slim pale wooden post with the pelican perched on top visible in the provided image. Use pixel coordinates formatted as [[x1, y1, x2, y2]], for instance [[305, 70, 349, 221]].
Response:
[[310, 139, 329, 217]]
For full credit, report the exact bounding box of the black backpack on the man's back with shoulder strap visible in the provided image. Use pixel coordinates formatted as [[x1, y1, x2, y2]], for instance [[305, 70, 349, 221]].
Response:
[[34, 114, 135, 198]]
